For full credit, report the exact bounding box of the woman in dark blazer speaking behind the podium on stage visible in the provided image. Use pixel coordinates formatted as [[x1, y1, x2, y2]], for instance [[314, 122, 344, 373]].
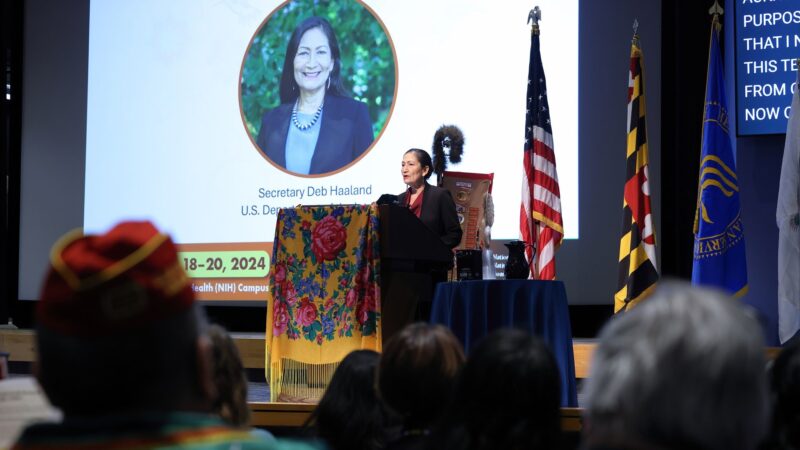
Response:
[[398, 148, 461, 249]]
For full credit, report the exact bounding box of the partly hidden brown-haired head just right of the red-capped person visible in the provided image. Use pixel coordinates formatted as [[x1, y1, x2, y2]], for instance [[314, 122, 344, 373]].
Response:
[[208, 325, 250, 428]]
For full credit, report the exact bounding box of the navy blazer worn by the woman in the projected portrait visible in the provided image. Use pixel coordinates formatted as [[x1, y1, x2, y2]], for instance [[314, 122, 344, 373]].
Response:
[[256, 95, 373, 175]]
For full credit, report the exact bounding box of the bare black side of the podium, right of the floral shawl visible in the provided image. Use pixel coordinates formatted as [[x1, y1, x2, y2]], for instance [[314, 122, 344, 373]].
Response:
[[378, 205, 453, 342]]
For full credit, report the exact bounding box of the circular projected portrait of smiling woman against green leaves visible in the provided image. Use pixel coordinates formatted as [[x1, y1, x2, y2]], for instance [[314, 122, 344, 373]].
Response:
[[239, 0, 397, 178]]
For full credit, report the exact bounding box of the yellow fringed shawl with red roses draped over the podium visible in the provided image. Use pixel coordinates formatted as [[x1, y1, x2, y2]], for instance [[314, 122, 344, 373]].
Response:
[[266, 205, 381, 402]]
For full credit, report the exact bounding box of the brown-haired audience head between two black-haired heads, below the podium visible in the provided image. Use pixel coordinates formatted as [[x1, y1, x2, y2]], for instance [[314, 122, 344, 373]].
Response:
[[378, 322, 464, 429]]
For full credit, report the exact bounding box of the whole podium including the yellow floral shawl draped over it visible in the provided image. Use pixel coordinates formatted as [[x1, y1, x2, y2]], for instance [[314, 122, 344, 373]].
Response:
[[265, 205, 453, 403]]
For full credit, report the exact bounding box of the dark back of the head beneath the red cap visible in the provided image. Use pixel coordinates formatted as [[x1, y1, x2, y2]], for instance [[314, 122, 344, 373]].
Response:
[[36, 304, 206, 417]]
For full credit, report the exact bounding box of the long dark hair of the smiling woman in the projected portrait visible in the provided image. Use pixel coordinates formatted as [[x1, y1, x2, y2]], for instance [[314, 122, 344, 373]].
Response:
[[280, 16, 349, 103]]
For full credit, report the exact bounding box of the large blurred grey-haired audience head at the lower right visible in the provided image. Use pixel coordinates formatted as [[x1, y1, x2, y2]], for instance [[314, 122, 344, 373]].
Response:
[[584, 282, 768, 450]]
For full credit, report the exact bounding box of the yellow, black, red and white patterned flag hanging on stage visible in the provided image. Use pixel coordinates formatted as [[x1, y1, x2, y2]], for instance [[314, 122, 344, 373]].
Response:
[[614, 34, 658, 312]]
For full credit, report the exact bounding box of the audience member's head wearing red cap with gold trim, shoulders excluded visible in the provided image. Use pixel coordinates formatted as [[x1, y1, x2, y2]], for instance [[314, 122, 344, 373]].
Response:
[[36, 222, 214, 417]]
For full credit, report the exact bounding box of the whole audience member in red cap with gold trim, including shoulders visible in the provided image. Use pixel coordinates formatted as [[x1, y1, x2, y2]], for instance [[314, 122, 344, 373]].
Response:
[[13, 222, 309, 450]]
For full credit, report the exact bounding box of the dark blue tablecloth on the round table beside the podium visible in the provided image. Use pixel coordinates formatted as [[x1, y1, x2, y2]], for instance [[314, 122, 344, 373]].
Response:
[[431, 280, 578, 406]]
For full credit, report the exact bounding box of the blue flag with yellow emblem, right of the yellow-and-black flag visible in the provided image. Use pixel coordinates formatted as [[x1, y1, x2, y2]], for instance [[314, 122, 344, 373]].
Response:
[[692, 14, 747, 296]]
